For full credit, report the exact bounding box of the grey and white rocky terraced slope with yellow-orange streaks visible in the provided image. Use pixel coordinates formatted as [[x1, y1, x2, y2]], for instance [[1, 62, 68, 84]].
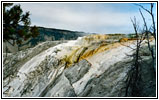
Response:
[[3, 35, 156, 97]]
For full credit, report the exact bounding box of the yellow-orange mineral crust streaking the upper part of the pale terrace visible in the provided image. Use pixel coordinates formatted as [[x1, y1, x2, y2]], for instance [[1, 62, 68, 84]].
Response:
[[63, 35, 132, 67]]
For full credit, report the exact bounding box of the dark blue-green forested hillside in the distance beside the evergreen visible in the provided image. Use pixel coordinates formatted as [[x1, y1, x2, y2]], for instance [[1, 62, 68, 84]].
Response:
[[22, 27, 87, 46]]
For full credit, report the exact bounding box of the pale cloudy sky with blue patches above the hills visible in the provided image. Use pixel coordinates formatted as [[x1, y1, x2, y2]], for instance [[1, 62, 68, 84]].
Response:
[[14, 3, 157, 34]]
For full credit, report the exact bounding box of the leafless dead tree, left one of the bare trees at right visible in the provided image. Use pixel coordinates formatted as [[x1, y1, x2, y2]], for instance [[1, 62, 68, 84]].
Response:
[[125, 17, 145, 96]]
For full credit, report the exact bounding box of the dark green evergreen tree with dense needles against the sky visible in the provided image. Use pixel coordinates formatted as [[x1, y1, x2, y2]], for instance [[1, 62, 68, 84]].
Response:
[[3, 3, 39, 48]]
